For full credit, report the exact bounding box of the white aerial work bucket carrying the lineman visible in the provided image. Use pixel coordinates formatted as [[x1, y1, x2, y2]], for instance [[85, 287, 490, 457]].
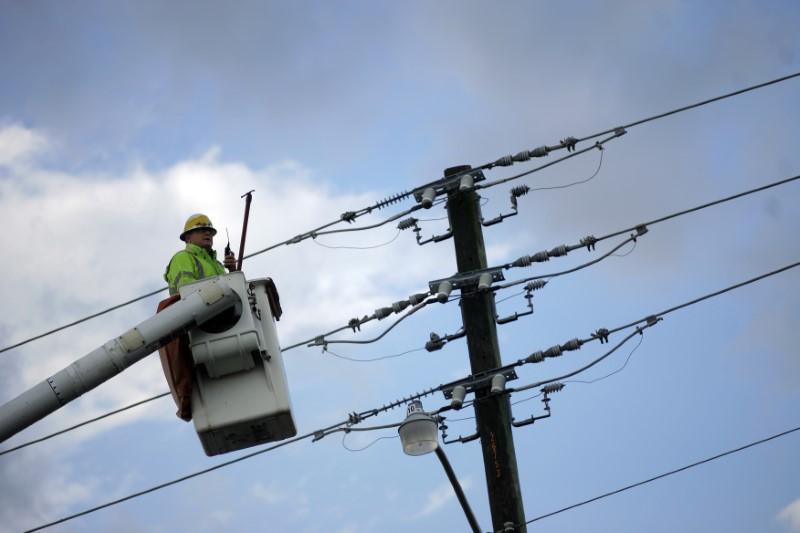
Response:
[[179, 272, 297, 456]]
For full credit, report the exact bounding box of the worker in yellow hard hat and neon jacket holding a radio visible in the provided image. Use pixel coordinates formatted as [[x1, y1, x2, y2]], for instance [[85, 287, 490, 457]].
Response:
[[164, 213, 236, 295]]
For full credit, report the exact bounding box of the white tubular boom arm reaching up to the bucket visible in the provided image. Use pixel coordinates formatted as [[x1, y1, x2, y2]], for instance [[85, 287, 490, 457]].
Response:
[[0, 278, 239, 442]]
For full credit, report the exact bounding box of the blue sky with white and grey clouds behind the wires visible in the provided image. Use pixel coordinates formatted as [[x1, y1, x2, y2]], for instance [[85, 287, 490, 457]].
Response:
[[0, 0, 800, 533]]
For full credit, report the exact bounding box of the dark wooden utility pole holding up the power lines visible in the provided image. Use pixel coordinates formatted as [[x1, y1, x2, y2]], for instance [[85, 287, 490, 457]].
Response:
[[444, 166, 527, 533]]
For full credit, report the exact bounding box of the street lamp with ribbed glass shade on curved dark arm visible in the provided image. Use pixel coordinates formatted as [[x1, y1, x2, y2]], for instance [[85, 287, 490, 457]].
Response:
[[397, 400, 481, 533]]
